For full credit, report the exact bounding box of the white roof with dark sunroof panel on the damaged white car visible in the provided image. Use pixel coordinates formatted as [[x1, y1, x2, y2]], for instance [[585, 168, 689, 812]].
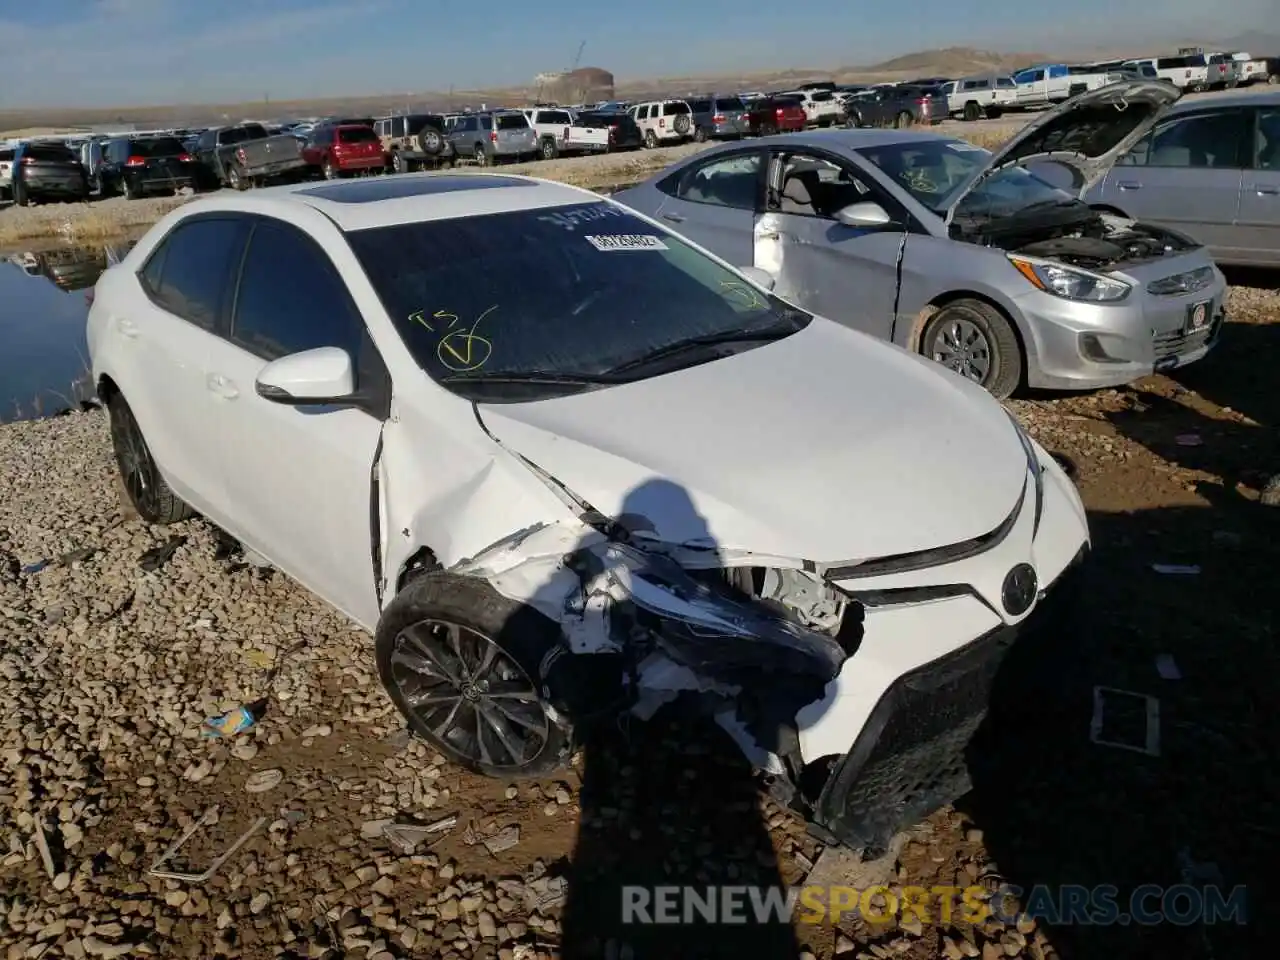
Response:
[[167, 173, 603, 232]]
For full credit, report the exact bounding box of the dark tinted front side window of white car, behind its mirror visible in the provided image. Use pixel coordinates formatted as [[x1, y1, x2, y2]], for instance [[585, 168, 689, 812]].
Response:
[[232, 220, 364, 362]]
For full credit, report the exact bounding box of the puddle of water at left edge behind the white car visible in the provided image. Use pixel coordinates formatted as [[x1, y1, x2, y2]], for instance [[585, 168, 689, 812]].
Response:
[[0, 241, 133, 422]]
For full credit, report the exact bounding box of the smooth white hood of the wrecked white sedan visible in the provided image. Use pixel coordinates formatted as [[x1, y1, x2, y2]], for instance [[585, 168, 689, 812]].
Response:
[[479, 319, 1027, 563]]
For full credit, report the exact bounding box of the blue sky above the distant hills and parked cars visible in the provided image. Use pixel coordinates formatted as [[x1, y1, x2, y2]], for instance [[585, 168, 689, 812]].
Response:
[[0, 0, 1259, 109]]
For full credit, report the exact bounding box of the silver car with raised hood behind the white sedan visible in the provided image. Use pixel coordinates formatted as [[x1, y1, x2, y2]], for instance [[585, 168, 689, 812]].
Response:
[[614, 81, 1226, 397]]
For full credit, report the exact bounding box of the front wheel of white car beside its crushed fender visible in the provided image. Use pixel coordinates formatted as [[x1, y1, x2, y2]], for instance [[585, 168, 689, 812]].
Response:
[[375, 573, 573, 778]]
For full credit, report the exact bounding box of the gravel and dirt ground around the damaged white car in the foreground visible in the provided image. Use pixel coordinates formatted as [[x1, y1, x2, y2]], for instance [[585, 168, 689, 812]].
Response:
[[0, 278, 1280, 960]]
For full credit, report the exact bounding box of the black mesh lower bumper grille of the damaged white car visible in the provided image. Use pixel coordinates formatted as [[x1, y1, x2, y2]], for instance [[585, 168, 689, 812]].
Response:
[[815, 552, 1083, 858]]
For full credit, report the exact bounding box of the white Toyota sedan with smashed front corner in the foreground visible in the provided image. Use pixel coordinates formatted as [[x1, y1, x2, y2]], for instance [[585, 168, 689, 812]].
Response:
[[88, 175, 1088, 851]]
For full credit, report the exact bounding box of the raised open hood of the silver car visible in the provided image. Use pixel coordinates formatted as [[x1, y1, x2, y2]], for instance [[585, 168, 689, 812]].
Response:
[[946, 79, 1181, 225]]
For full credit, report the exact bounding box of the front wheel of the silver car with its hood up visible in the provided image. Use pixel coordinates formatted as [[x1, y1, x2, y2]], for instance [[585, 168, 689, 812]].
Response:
[[920, 298, 1023, 399]]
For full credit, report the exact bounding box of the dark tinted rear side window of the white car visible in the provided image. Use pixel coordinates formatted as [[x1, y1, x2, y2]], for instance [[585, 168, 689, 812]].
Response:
[[142, 219, 246, 330]]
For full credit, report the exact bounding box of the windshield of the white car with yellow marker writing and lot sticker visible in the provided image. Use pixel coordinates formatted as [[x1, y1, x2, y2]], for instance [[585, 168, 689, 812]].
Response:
[[348, 201, 812, 402]]
